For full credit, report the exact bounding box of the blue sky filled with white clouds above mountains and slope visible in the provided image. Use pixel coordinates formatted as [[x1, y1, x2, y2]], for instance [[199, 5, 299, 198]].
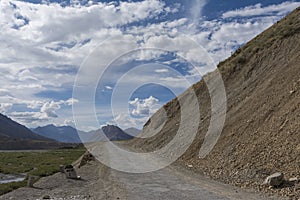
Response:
[[0, 0, 300, 130]]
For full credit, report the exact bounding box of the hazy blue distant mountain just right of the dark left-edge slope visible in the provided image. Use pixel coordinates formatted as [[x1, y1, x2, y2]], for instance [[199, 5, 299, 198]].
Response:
[[32, 124, 81, 143]]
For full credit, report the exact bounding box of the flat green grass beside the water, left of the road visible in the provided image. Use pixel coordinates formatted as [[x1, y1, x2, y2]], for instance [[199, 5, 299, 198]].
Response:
[[0, 148, 86, 195]]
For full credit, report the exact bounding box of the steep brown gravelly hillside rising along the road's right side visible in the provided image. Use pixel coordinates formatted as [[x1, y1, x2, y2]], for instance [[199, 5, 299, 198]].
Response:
[[132, 8, 300, 198]]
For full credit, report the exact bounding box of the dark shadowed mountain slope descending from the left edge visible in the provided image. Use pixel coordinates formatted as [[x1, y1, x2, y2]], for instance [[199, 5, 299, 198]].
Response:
[[0, 114, 65, 150]]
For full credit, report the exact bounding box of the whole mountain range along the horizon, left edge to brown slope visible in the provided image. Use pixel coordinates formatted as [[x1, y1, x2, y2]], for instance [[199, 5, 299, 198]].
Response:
[[0, 114, 140, 150]]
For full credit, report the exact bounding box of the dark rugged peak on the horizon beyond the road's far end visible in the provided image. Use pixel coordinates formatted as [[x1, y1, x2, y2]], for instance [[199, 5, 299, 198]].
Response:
[[101, 125, 134, 141]]
